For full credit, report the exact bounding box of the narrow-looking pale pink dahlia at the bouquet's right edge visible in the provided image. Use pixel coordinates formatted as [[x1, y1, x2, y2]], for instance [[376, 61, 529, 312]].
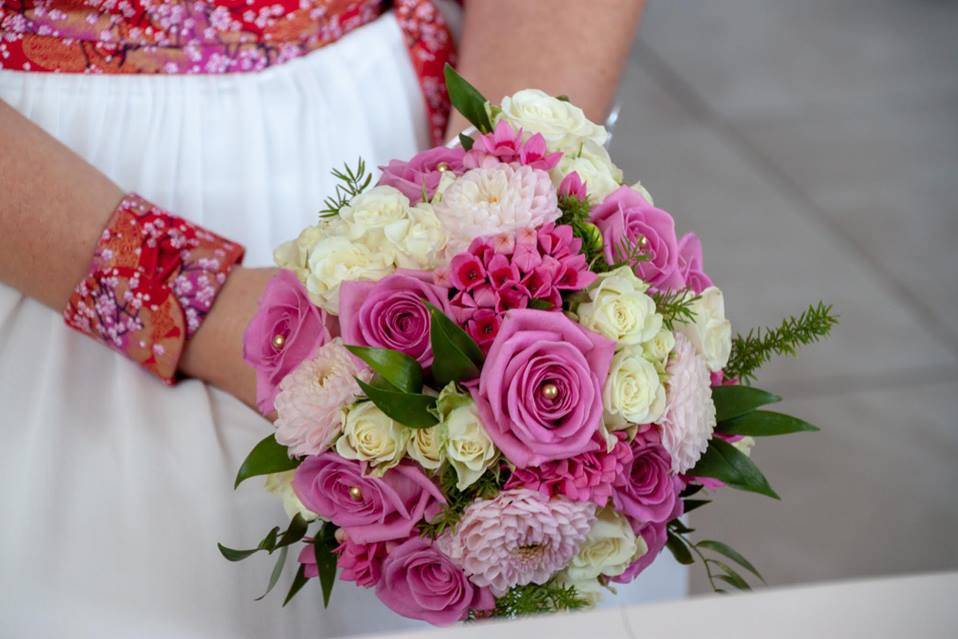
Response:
[[661, 333, 715, 473]]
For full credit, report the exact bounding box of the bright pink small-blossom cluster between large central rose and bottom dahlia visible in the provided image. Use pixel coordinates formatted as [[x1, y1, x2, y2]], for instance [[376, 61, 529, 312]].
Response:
[[506, 433, 632, 507]]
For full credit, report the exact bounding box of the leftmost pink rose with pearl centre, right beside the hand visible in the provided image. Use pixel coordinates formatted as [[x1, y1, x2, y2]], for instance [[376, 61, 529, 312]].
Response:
[[243, 270, 330, 415]]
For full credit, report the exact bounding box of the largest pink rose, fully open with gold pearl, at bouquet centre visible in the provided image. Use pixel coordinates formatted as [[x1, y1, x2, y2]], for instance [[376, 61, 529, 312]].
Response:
[[472, 309, 615, 468]]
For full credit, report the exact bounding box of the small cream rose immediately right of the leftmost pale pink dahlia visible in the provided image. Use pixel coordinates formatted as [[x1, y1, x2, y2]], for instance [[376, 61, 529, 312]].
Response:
[[336, 402, 412, 475]]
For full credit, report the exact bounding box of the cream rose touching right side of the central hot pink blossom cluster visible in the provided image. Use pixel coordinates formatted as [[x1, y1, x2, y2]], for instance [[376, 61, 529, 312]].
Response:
[[576, 266, 662, 344]]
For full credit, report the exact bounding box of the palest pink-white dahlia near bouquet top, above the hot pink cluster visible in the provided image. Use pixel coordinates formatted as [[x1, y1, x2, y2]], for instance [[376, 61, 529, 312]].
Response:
[[435, 164, 560, 254]]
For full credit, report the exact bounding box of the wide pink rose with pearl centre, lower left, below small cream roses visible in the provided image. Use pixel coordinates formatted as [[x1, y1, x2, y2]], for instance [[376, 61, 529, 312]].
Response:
[[293, 452, 446, 544]]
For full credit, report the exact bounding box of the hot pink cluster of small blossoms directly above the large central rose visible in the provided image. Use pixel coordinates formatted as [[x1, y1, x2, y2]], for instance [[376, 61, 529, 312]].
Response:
[[439, 223, 596, 350]]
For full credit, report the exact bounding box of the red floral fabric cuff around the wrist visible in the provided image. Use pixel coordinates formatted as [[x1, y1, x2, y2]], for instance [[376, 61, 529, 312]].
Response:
[[63, 194, 243, 384]]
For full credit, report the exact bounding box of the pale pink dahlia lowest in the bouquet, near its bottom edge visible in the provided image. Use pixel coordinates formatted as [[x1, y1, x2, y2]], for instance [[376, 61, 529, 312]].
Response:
[[438, 488, 595, 597]]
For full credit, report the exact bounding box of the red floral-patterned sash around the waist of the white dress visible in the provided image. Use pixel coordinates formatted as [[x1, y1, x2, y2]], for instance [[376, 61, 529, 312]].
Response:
[[0, 0, 454, 144]]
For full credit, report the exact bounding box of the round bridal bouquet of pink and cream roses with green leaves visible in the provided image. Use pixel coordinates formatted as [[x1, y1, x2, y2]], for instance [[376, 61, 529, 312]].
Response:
[[220, 68, 835, 625]]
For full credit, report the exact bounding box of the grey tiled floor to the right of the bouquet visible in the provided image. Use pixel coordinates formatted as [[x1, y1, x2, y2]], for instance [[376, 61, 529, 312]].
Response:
[[612, 0, 958, 592]]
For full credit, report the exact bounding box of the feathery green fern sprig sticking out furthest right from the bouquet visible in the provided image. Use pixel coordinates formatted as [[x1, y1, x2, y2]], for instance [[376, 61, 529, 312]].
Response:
[[725, 302, 838, 382]]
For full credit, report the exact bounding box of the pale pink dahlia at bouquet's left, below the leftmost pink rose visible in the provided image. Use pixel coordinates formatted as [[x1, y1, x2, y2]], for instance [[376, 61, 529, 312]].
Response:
[[275, 338, 371, 456]]
